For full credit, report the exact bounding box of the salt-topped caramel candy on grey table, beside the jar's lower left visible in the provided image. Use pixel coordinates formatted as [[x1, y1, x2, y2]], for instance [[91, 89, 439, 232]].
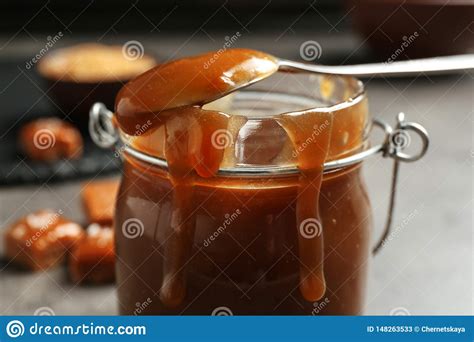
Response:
[[69, 223, 115, 284]]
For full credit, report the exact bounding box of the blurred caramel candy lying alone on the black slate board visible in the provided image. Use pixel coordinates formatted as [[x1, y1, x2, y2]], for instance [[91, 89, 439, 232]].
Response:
[[19, 118, 83, 161]]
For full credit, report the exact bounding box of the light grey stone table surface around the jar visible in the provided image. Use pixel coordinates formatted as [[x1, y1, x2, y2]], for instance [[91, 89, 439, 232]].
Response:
[[0, 34, 474, 315]]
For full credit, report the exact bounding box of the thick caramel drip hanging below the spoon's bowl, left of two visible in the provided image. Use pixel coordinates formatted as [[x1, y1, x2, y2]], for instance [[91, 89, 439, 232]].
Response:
[[160, 107, 237, 307]]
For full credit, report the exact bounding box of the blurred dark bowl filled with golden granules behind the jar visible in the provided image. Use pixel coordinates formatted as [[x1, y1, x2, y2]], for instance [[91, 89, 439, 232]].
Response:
[[38, 44, 156, 132]]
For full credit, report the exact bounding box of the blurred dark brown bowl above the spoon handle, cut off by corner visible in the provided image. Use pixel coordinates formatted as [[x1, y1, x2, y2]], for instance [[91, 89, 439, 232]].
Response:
[[347, 0, 474, 60]]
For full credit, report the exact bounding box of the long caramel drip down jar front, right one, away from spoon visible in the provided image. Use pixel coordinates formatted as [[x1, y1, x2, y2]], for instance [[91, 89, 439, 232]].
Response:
[[278, 112, 332, 301]]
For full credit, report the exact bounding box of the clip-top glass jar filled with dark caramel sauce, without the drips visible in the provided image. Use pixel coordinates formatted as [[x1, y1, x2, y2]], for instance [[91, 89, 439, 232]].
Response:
[[91, 74, 430, 315]]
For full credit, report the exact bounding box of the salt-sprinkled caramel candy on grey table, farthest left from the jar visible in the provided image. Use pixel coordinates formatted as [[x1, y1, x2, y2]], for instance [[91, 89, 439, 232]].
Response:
[[5, 209, 84, 270]]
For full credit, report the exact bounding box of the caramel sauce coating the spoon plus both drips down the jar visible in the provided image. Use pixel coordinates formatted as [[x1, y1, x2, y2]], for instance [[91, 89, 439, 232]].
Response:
[[116, 49, 350, 308]]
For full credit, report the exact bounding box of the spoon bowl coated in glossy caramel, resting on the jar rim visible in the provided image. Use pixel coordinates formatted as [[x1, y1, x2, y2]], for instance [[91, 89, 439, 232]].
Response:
[[115, 49, 278, 135]]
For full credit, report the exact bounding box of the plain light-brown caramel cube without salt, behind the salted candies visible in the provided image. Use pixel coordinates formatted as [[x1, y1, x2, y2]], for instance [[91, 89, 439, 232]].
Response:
[[82, 179, 120, 226]]
